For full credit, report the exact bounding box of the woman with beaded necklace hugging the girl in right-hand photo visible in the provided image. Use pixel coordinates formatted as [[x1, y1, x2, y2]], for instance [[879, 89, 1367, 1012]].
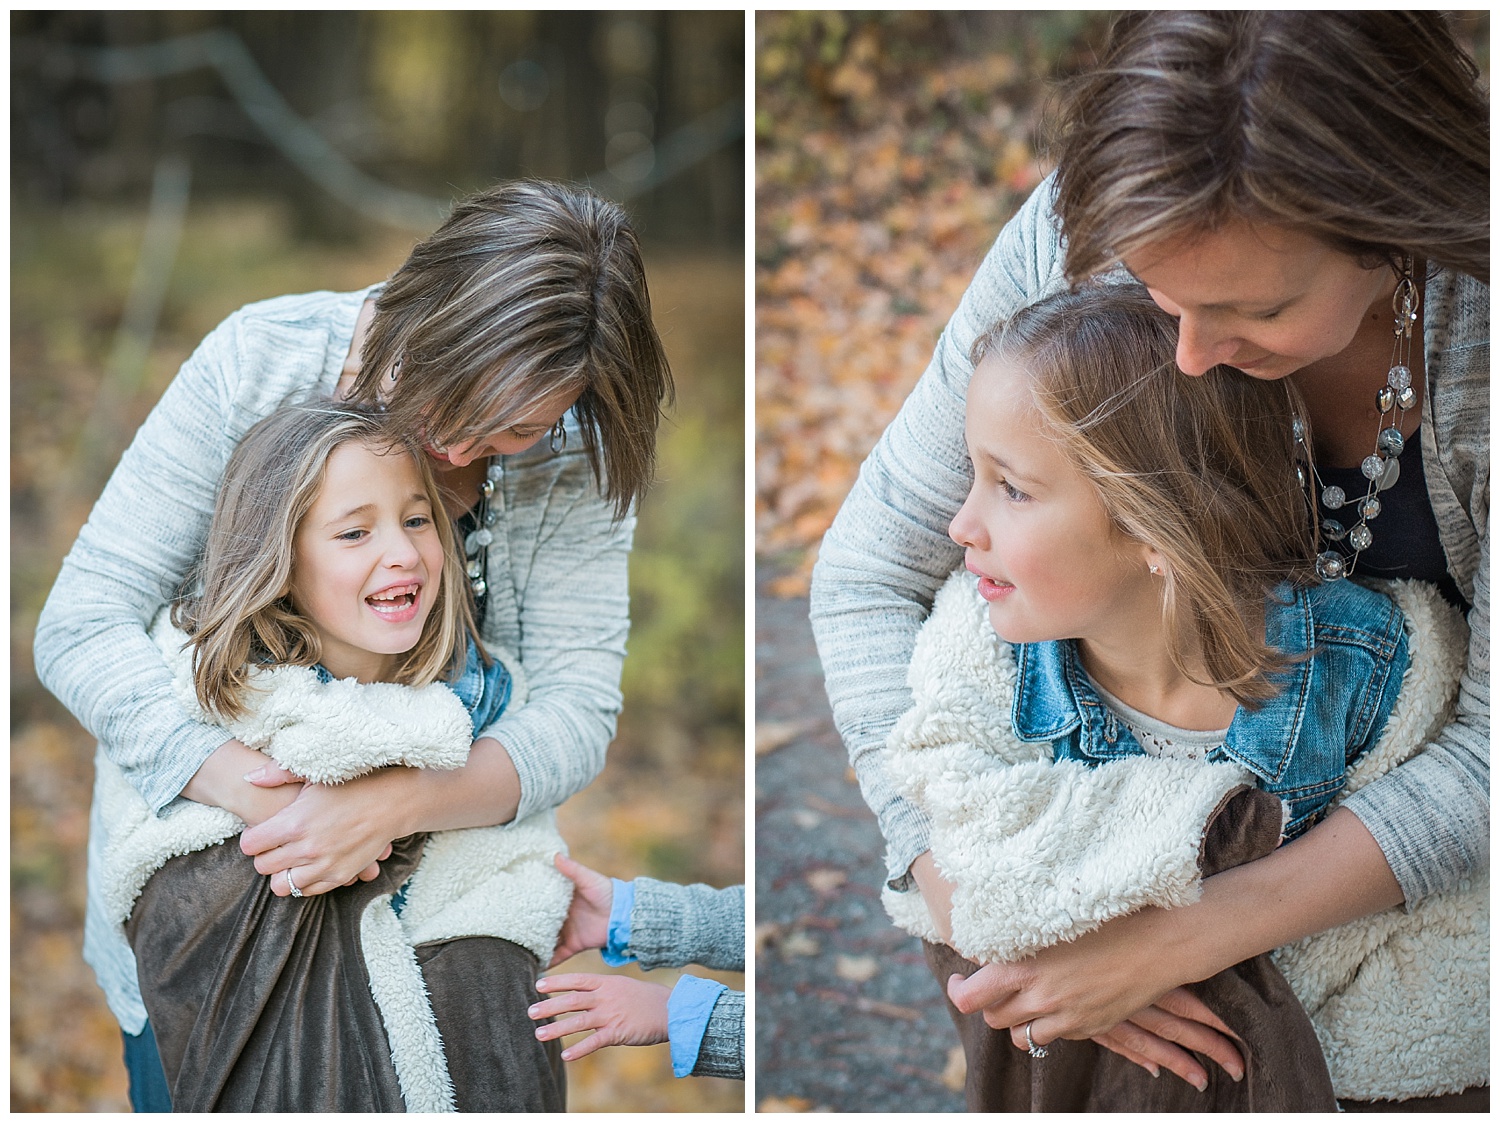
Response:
[[813, 12, 1490, 1110]]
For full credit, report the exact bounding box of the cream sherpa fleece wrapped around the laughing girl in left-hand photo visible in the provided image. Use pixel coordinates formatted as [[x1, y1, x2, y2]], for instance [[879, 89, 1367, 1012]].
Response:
[[95, 609, 572, 1111]]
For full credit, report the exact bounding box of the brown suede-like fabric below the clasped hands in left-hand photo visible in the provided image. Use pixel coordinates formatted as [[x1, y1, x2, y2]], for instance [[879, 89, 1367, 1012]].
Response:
[[126, 835, 566, 1111]]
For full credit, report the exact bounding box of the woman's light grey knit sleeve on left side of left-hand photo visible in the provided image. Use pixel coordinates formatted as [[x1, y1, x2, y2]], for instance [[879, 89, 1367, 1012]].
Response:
[[35, 292, 363, 811]]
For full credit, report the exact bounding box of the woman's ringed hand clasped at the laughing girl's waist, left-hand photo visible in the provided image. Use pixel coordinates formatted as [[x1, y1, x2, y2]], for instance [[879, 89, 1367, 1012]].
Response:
[[240, 769, 411, 897]]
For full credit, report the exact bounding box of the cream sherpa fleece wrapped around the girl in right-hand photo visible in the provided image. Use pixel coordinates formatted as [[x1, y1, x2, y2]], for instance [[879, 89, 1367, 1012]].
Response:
[[884, 573, 1490, 1101]]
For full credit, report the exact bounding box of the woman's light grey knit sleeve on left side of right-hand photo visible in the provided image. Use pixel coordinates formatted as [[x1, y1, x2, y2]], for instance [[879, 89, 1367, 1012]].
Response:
[[812, 178, 1064, 882]]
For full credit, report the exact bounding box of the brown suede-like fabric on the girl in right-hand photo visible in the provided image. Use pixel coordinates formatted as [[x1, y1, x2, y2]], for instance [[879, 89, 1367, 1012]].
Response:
[[924, 789, 1338, 1111]]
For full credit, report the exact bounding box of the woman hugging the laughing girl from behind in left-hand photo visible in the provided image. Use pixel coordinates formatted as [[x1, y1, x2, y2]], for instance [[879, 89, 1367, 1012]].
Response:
[[36, 183, 671, 1107]]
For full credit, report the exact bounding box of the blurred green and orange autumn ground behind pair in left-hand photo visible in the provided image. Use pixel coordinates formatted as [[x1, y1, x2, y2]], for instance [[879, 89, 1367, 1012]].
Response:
[[11, 202, 746, 1111]]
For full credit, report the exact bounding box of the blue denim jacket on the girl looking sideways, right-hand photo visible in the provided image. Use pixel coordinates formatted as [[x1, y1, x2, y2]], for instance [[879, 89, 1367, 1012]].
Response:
[[1011, 580, 1410, 838]]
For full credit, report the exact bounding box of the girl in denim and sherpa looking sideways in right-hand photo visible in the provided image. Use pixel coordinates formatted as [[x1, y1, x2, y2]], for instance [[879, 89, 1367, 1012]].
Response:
[[887, 285, 1487, 1110]]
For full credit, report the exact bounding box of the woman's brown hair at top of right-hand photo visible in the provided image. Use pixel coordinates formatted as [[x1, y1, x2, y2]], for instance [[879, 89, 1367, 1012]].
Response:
[[1055, 9, 1490, 283]]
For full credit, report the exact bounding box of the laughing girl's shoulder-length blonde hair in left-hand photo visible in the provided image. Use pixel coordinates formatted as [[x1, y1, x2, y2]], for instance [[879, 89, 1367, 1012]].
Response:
[[173, 402, 476, 720]]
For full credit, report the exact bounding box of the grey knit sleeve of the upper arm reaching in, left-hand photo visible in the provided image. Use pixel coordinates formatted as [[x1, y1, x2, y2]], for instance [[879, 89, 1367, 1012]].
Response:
[[630, 877, 746, 972]]
